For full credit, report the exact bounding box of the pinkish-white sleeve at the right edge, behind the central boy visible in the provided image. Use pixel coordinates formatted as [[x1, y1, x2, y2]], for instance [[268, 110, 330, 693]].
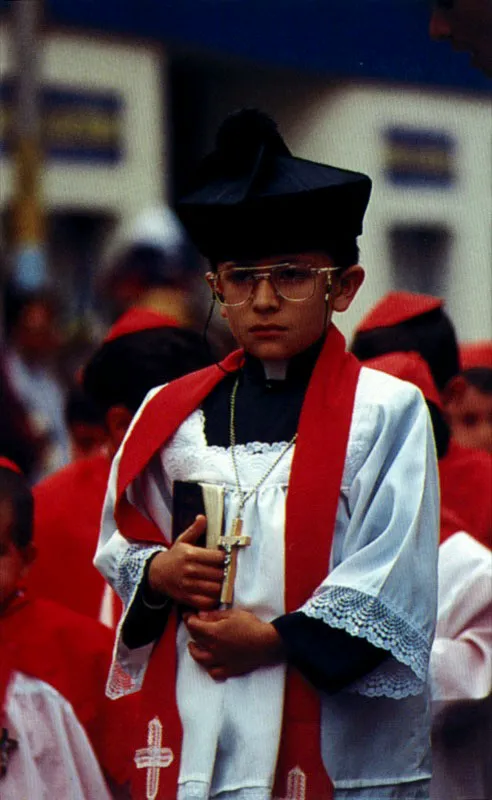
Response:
[[431, 533, 492, 702]]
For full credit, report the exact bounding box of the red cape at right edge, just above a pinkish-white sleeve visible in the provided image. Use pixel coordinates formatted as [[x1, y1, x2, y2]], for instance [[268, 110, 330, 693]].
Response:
[[439, 439, 492, 547]]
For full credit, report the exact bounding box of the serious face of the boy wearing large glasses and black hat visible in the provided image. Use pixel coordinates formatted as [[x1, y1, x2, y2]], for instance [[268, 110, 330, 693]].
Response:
[[213, 253, 364, 361]]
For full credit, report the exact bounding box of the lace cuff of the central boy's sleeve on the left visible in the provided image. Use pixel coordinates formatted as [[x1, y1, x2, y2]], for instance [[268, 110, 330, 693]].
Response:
[[106, 545, 166, 700]]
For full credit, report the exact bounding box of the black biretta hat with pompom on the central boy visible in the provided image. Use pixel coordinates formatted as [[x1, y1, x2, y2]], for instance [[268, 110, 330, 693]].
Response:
[[177, 109, 371, 262]]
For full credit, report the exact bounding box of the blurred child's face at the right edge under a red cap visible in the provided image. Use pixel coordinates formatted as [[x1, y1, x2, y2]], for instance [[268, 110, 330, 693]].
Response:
[[445, 383, 492, 453]]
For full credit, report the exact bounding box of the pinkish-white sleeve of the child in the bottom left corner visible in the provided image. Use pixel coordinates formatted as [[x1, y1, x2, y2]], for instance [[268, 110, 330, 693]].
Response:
[[1, 673, 111, 800]]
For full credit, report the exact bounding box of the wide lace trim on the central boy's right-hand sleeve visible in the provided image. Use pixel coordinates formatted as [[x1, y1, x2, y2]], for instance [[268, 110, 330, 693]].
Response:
[[300, 586, 430, 698]]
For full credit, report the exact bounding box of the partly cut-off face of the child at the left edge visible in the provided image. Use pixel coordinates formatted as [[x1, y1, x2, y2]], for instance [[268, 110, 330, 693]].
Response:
[[0, 499, 33, 614]]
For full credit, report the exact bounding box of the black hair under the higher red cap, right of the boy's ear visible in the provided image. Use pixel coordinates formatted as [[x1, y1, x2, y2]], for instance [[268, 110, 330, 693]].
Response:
[[350, 308, 460, 391]]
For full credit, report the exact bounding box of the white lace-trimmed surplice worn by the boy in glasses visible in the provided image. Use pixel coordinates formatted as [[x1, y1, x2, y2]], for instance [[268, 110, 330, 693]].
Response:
[[95, 368, 439, 800]]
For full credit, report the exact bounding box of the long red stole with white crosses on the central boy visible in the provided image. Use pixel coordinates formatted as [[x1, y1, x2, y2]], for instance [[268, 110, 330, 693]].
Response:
[[115, 325, 360, 800]]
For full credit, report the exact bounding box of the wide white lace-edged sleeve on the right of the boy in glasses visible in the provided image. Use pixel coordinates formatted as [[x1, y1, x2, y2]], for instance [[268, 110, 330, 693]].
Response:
[[301, 368, 439, 698]]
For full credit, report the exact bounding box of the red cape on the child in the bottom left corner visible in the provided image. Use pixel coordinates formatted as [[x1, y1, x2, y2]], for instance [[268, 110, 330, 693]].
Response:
[[0, 598, 135, 784]]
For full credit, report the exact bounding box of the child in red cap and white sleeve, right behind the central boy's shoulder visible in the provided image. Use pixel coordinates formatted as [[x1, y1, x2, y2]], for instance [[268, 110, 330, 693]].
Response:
[[365, 353, 492, 800]]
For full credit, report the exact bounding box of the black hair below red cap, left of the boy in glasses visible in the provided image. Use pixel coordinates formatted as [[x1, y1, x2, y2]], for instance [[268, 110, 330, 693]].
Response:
[[83, 327, 213, 414]]
